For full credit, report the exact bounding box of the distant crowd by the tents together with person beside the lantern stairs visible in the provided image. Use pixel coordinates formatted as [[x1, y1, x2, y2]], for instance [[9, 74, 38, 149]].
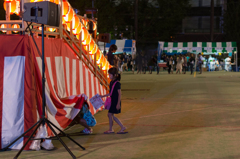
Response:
[[106, 45, 232, 74]]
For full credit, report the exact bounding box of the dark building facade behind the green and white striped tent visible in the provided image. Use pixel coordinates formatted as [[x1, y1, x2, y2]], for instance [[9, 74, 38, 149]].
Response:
[[173, 0, 227, 41]]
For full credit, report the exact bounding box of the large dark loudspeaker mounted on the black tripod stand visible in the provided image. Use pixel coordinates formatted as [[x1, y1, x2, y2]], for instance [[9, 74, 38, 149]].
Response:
[[23, 1, 60, 27]]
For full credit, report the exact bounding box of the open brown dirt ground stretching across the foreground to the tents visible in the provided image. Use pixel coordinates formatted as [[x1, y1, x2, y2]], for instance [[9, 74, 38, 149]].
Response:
[[0, 71, 240, 159]]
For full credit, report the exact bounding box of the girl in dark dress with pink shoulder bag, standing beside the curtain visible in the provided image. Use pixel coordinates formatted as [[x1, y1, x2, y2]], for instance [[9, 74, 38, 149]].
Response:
[[101, 67, 127, 134]]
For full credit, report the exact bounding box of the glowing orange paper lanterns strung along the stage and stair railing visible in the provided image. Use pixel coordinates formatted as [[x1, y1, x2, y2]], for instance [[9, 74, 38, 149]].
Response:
[[1, 0, 111, 70]]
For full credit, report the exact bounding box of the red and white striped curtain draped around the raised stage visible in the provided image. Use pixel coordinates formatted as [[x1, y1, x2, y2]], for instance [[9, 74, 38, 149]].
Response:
[[0, 35, 106, 149]]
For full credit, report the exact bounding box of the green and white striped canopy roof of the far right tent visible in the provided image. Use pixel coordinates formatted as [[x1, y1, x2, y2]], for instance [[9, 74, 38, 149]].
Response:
[[158, 41, 237, 54]]
